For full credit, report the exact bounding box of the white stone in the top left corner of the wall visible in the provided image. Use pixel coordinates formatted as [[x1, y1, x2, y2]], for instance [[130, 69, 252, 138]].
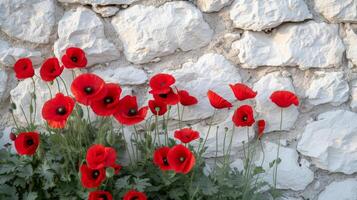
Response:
[[0, 0, 55, 43]]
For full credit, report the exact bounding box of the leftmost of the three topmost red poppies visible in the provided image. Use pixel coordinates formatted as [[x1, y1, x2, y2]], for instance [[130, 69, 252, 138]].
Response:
[[14, 58, 35, 80]]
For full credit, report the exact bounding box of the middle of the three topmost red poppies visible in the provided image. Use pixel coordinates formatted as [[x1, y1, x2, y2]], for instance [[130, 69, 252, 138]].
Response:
[[40, 57, 63, 81]]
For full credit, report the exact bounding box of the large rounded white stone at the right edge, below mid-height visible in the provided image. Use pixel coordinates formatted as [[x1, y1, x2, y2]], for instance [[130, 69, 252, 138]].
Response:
[[297, 110, 357, 174]]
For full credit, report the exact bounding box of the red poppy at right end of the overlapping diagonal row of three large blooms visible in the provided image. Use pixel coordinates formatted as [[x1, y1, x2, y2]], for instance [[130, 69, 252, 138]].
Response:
[[114, 95, 149, 126]]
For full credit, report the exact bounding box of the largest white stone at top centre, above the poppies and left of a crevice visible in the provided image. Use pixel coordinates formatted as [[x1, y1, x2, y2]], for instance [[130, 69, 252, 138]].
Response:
[[112, 1, 213, 64]]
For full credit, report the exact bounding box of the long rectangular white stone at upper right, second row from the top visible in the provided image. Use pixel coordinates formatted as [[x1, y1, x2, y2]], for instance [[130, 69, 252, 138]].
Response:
[[232, 21, 345, 69]]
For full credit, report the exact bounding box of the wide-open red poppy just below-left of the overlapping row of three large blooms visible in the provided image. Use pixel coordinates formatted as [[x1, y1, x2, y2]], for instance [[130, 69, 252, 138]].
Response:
[[42, 93, 75, 128]]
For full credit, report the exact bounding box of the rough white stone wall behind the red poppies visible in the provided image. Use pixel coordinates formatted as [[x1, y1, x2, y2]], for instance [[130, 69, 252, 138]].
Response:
[[0, 0, 357, 200]]
